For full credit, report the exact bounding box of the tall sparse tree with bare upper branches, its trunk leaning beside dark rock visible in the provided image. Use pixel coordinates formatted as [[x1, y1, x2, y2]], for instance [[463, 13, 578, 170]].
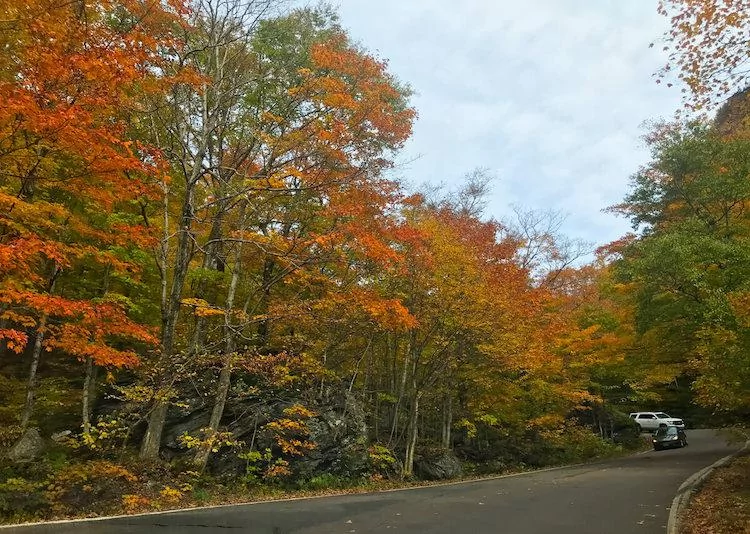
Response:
[[134, 0, 280, 460]]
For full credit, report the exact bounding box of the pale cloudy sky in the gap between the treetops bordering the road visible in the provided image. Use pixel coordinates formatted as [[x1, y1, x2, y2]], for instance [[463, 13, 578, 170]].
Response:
[[333, 0, 680, 250]]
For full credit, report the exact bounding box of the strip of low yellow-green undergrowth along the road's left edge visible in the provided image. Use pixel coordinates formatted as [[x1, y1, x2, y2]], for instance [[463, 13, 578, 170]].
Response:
[[0, 438, 648, 524]]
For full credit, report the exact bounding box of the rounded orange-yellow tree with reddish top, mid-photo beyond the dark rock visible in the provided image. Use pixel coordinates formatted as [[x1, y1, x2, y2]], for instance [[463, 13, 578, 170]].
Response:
[[358, 194, 560, 476]]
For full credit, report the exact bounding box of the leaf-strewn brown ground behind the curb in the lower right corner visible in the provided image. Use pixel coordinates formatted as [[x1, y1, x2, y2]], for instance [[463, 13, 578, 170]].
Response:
[[680, 454, 750, 534]]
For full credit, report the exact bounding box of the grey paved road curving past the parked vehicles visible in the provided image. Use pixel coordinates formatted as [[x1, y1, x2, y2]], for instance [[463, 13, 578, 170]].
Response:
[[0, 430, 738, 534]]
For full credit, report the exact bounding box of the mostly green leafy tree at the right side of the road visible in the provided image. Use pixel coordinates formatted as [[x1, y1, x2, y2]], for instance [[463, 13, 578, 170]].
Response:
[[615, 124, 750, 409]]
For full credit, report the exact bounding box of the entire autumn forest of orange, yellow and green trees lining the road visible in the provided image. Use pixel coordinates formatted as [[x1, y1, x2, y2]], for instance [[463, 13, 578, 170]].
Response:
[[0, 0, 750, 522]]
